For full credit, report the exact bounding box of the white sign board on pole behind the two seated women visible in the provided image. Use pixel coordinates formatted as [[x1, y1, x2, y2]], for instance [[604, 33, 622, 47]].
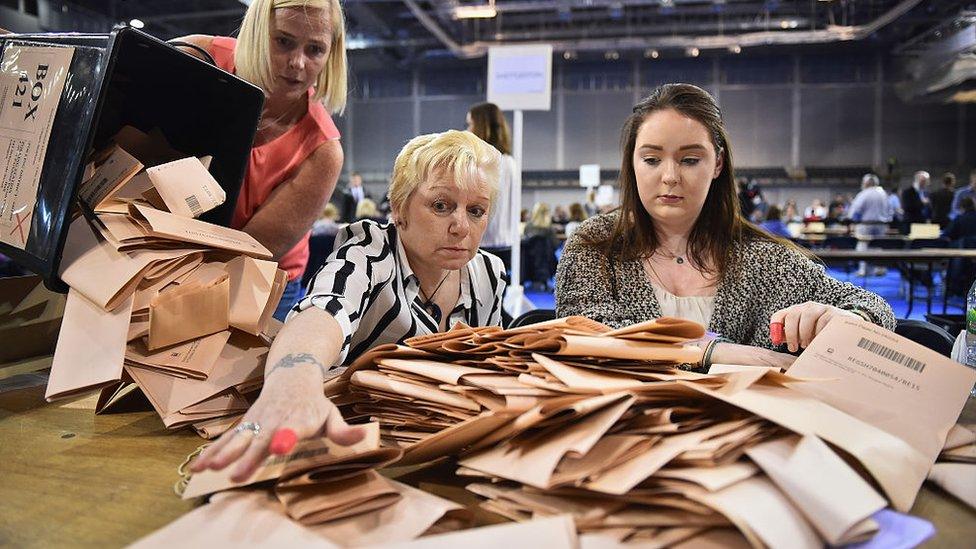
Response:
[[488, 44, 552, 111]]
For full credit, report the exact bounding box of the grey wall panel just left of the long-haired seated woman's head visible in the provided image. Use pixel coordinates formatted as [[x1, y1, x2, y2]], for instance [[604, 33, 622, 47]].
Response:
[[563, 92, 633, 169]]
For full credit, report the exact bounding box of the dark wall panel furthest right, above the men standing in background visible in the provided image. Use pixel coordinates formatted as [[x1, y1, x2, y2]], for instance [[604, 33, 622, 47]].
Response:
[[881, 87, 959, 166]]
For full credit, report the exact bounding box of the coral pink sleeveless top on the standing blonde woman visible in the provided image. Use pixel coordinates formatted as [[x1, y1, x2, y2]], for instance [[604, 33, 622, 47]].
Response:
[[210, 36, 339, 280]]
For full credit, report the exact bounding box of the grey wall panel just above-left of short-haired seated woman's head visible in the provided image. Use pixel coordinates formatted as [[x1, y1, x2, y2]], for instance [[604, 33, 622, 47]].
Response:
[[349, 99, 414, 173]]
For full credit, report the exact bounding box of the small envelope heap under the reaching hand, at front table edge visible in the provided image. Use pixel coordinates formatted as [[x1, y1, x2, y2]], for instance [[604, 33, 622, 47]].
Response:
[[136, 423, 471, 547]]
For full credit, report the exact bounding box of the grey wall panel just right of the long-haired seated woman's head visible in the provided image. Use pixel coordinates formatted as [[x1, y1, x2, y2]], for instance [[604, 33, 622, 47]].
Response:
[[720, 87, 793, 167]]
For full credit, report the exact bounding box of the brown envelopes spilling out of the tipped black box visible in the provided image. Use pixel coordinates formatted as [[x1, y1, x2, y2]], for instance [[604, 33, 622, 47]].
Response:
[[46, 128, 287, 437]]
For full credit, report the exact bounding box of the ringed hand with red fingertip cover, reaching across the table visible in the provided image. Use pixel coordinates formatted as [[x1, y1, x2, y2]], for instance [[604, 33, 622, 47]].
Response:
[[190, 362, 364, 482]]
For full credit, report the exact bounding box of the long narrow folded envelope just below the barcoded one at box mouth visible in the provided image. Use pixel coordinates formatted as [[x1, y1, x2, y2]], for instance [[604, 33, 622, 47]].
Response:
[[129, 204, 271, 259]]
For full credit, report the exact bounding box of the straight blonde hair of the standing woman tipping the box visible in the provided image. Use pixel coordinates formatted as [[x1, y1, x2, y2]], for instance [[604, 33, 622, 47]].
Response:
[[234, 0, 347, 114]]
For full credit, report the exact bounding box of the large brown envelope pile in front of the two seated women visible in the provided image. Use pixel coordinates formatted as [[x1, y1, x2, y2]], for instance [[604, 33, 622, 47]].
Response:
[[326, 318, 973, 547]]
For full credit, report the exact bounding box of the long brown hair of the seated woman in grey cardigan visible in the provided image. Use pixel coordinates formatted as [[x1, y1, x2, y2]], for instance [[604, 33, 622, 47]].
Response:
[[591, 84, 791, 278]]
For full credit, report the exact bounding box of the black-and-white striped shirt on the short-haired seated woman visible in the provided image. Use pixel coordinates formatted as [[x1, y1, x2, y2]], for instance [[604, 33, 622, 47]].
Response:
[[289, 220, 508, 364]]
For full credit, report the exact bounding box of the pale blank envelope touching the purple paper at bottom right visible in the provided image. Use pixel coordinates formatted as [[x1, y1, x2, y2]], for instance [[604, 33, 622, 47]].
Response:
[[746, 435, 888, 545]]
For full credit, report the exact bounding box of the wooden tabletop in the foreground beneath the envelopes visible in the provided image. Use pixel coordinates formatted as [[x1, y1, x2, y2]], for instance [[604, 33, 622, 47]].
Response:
[[0, 374, 976, 548]]
